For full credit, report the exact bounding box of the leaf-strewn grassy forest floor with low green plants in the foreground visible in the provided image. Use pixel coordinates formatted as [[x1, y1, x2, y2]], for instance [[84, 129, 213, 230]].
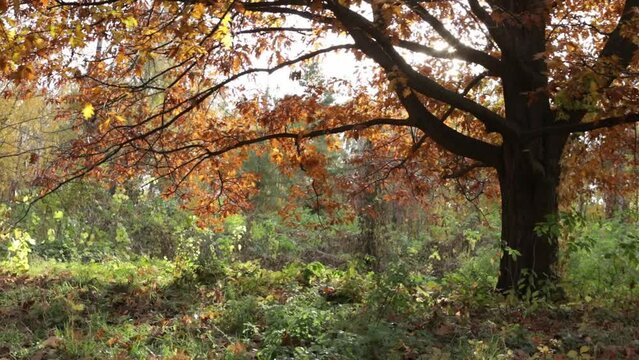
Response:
[[0, 260, 639, 360]]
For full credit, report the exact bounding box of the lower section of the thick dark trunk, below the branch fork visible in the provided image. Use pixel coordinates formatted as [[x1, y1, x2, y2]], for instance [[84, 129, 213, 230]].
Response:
[[497, 139, 563, 295]]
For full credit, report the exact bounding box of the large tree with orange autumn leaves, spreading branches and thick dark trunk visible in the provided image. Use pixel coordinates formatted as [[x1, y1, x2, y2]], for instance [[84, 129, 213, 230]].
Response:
[[0, 0, 639, 290]]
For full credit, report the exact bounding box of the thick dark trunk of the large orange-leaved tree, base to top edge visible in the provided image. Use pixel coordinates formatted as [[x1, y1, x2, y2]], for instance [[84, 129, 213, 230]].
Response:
[[497, 1, 567, 295]]
